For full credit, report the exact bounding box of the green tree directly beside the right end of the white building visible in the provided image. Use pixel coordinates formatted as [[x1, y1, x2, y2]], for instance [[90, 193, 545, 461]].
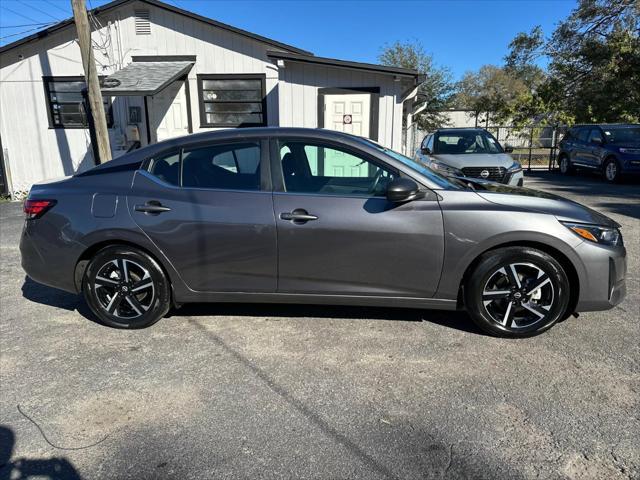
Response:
[[378, 41, 454, 131]]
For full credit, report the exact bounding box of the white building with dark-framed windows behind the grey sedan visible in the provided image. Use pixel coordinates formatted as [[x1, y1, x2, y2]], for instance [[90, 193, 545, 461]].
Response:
[[0, 0, 419, 194]]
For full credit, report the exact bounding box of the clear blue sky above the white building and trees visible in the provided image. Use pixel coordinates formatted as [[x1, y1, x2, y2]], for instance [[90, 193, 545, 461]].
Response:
[[0, 0, 576, 80]]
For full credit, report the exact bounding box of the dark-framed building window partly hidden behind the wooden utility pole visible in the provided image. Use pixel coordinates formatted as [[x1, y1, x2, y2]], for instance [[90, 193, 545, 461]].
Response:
[[43, 77, 113, 128]]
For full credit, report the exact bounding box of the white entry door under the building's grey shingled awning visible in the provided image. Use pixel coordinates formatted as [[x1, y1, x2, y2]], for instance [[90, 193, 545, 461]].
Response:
[[150, 80, 189, 142]]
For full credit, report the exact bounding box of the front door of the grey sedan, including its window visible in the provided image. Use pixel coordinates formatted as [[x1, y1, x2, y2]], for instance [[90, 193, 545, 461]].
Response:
[[271, 138, 444, 298]]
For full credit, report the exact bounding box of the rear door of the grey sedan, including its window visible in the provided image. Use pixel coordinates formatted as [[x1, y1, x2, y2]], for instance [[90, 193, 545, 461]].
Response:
[[128, 139, 277, 292]]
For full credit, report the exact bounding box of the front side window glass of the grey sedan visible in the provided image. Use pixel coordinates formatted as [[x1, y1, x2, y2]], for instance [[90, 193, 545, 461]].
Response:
[[280, 140, 398, 196]]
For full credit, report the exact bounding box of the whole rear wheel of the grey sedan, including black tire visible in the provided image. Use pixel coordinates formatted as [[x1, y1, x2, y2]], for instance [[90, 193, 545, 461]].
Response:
[[82, 245, 171, 329]]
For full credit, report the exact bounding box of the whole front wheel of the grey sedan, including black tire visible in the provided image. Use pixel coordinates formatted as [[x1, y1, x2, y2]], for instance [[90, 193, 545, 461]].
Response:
[[465, 247, 570, 338]]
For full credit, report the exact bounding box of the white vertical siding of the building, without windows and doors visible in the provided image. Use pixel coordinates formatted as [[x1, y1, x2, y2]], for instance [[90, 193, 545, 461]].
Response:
[[0, 2, 410, 191]]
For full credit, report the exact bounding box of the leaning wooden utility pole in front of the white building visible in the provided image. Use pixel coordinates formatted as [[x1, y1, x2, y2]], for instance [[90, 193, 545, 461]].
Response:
[[71, 0, 111, 163]]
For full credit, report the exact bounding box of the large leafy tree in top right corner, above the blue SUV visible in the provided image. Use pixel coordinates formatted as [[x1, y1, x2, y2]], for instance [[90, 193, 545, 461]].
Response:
[[505, 0, 640, 122]]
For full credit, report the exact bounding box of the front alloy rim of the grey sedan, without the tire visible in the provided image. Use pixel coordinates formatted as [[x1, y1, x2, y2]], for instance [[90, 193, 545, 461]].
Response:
[[482, 263, 555, 330]]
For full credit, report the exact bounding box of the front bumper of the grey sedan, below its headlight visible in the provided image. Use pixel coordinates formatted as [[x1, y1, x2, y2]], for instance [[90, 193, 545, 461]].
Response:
[[576, 241, 627, 312]]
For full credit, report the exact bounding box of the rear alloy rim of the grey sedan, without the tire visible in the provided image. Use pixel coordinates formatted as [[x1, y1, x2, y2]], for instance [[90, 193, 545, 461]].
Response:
[[94, 258, 155, 319]]
